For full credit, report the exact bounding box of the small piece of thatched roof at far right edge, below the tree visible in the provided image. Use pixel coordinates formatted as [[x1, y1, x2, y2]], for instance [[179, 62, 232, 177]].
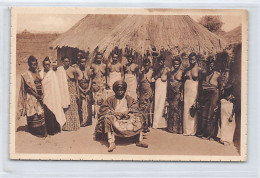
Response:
[[222, 25, 242, 43]]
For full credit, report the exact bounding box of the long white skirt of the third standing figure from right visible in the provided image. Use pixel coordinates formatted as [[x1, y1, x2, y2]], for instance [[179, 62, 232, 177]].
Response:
[[183, 79, 198, 135]]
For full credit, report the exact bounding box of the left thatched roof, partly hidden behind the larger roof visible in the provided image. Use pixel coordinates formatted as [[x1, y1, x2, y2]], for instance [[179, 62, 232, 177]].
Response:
[[50, 14, 127, 51]]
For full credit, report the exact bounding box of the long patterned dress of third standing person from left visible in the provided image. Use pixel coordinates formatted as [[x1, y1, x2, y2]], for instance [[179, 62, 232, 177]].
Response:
[[62, 75, 80, 131]]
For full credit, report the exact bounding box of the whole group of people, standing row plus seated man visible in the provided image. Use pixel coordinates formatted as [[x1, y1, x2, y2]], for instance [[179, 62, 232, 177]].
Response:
[[18, 46, 238, 152]]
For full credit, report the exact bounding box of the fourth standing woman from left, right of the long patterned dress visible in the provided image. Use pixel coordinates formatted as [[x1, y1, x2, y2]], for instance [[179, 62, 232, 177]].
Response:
[[78, 58, 92, 127]]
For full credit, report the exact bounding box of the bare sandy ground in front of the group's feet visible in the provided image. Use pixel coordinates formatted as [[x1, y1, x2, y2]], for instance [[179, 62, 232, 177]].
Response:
[[16, 119, 239, 156]]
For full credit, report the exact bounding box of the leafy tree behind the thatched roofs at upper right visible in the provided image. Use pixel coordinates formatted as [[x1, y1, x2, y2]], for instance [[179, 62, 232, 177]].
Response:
[[199, 15, 223, 32]]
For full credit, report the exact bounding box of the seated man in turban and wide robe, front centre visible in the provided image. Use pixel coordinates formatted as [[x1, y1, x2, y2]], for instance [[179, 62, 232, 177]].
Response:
[[95, 80, 148, 152]]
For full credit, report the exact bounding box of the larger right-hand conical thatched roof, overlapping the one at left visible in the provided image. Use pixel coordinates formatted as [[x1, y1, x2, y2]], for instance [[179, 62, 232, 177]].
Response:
[[98, 15, 225, 56]]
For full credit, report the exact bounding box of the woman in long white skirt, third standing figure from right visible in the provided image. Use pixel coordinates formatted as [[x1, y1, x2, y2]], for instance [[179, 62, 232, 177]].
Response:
[[183, 52, 199, 135]]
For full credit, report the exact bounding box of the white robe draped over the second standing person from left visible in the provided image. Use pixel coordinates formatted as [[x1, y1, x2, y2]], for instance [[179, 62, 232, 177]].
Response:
[[40, 70, 66, 127]]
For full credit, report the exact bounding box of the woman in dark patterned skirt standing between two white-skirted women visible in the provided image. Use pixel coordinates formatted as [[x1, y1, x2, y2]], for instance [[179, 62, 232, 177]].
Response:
[[167, 56, 183, 134]]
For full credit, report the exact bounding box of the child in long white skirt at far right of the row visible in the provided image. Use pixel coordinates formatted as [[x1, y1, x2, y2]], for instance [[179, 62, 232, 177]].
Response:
[[218, 85, 236, 146]]
